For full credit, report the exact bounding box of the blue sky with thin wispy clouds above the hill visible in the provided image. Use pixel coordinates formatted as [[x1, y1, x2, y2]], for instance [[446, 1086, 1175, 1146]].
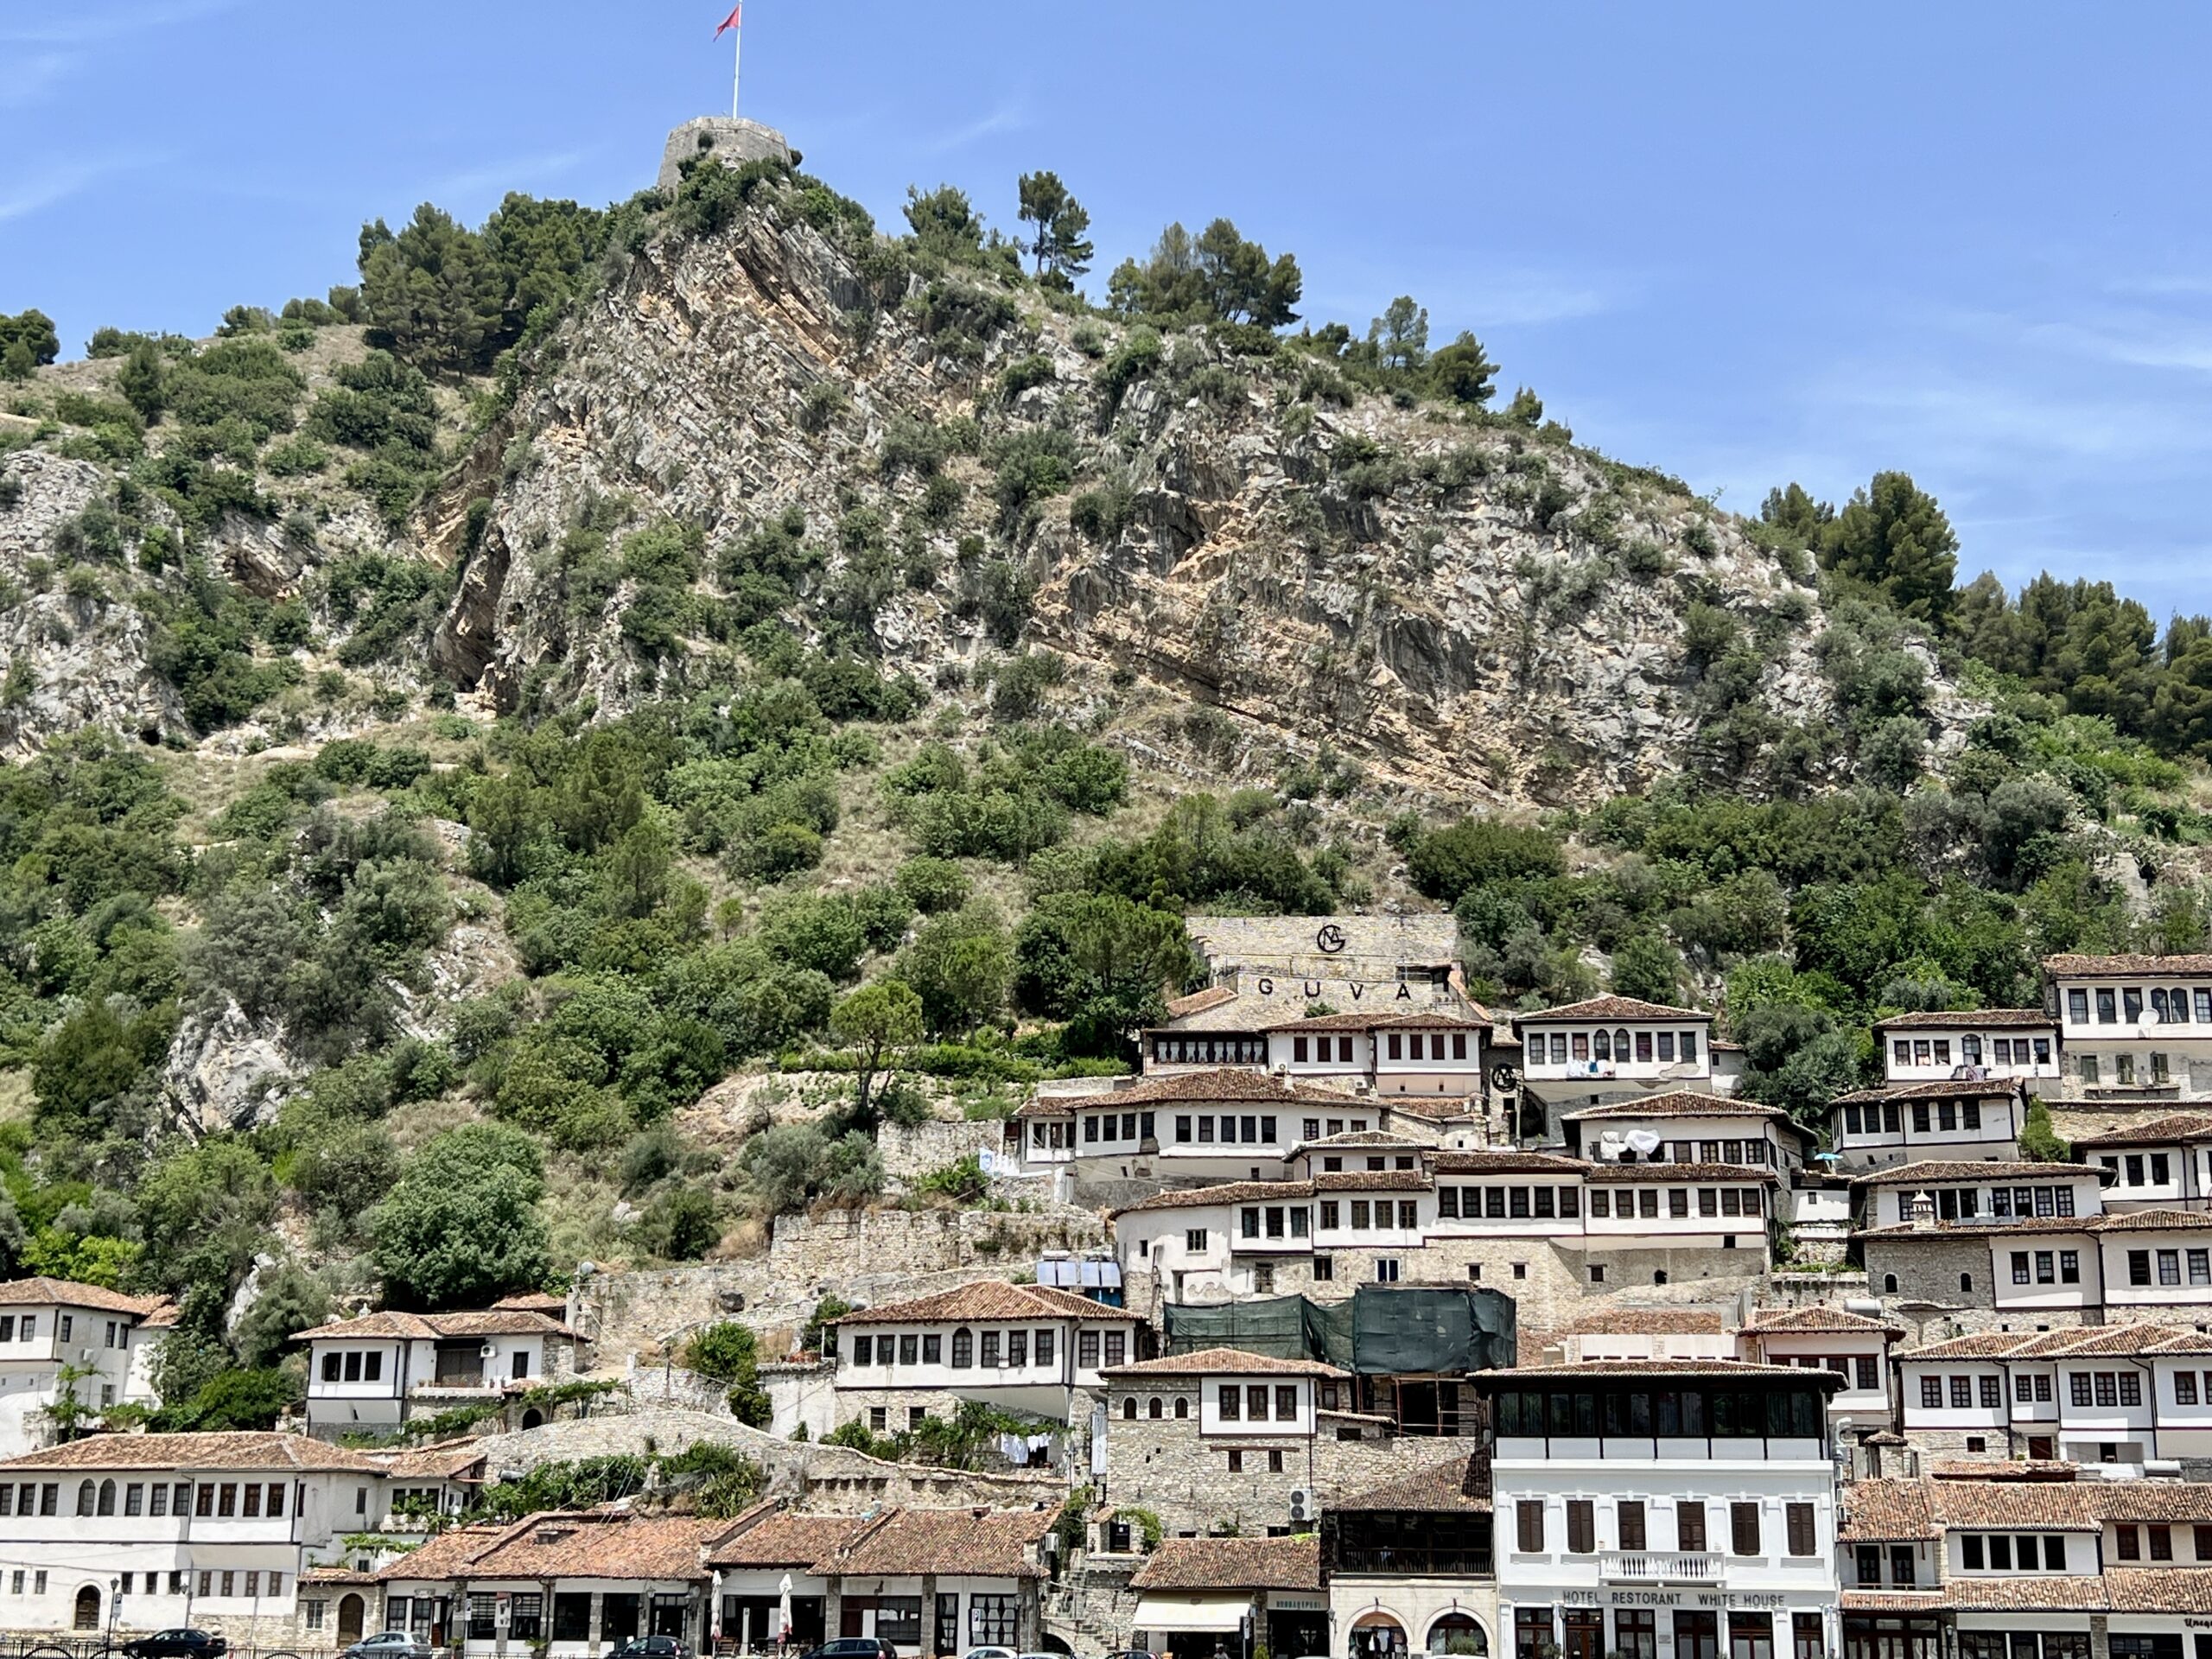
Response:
[[0, 0, 2212, 620]]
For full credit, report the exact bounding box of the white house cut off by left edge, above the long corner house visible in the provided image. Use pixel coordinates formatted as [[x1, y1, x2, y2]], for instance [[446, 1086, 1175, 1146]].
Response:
[[0, 1279, 166, 1455]]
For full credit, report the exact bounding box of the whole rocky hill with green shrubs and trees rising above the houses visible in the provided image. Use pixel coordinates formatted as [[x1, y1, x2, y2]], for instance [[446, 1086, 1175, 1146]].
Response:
[[0, 149, 2212, 1427]]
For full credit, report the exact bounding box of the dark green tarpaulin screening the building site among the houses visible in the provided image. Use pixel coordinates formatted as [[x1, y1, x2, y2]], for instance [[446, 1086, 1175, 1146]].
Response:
[[1164, 1285, 1516, 1376]]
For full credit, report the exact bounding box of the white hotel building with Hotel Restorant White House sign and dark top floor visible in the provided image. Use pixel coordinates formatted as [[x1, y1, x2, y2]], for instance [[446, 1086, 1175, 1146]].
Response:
[[1473, 1360, 1842, 1659]]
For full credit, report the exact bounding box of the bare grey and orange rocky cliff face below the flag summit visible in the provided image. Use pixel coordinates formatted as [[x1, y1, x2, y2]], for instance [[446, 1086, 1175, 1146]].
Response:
[[431, 180, 1974, 803]]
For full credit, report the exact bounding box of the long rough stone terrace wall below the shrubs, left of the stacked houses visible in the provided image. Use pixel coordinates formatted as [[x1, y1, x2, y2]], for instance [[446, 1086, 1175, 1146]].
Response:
[[575, 1208, 1106, 1367]]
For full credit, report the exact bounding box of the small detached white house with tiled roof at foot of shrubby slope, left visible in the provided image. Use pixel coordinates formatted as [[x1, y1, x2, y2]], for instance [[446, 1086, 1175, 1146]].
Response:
[[292, 1307, 577, 1438]]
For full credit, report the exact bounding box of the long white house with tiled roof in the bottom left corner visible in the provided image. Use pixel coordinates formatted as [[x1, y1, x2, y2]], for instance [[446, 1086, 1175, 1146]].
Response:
[[0, 1433, 387, 1646]]
